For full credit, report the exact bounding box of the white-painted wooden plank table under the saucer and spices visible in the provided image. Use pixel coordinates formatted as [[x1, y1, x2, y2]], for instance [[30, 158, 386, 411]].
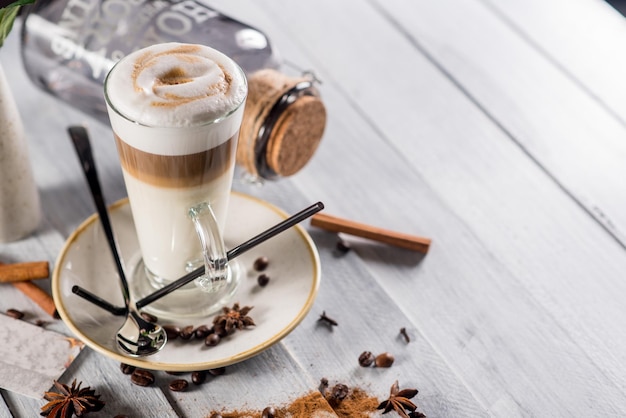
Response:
[[0, 0, 626, 417]]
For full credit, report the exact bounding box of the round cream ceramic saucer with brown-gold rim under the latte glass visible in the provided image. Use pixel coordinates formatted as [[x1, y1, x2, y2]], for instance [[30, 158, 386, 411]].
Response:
[[52, 193, 320, 371]]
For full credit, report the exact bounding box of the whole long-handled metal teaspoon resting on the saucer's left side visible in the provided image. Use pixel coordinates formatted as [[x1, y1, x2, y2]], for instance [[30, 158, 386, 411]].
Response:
[[68, 126, 167, 357]]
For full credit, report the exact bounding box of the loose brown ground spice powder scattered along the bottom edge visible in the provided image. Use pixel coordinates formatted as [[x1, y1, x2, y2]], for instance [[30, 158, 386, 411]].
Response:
[[209, 388, 380, 418]]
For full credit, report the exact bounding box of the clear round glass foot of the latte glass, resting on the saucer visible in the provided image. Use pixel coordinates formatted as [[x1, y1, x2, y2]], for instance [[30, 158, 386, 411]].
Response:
[[130, 258, 245, 320]]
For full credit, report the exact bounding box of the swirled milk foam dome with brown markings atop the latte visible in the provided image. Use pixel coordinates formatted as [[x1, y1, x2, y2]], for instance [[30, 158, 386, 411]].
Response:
[[106, 43, 247, 126]]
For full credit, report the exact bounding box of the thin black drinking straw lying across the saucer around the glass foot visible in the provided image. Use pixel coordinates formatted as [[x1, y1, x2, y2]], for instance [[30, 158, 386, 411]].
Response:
[[72, 202, 324, 315]]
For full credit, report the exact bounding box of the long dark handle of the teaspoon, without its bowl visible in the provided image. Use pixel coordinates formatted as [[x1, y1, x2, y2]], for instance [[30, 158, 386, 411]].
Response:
[[67, 126, 130, 306]]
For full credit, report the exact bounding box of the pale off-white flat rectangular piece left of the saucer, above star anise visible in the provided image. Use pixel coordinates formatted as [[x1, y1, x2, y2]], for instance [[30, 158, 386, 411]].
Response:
[[0, 314, 84, 399]]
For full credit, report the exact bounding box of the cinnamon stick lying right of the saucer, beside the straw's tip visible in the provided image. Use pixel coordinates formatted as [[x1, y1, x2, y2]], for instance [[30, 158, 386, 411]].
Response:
[[311, 213, 431, 254]]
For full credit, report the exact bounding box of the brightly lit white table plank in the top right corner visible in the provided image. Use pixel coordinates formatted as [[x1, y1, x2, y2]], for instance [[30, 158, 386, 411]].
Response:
[[481, 0, 626, 122]]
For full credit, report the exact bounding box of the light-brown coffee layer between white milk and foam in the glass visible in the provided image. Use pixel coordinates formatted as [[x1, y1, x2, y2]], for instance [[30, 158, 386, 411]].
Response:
[[115, 133, 238, 188]]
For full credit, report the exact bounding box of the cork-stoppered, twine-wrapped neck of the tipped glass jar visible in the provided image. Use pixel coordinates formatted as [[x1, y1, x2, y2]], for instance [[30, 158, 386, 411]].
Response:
[[237, 69, 326, 179]]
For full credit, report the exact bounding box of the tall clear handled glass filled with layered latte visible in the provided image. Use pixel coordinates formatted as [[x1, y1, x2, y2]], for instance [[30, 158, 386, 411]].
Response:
[[104, 43, 247, 317]]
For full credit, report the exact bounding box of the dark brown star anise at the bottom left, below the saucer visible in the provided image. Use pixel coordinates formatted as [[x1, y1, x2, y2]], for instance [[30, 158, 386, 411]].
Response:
[[41, 379, 104, 418]]
